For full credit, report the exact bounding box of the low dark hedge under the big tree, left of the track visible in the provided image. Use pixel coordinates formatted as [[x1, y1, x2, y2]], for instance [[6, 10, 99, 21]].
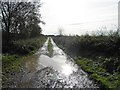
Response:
[[3, 37, 45, 55]]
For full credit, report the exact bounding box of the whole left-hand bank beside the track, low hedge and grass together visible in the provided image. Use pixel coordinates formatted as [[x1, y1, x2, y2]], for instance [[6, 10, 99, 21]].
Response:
[[2, 37, 45, 84]]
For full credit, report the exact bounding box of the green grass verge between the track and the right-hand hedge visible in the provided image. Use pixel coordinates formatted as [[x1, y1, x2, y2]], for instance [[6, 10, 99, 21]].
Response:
[[76, 57, 120, 89]]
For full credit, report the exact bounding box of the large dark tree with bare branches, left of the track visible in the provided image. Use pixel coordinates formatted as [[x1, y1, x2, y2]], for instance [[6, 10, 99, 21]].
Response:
[[0, 2, 44, 41]]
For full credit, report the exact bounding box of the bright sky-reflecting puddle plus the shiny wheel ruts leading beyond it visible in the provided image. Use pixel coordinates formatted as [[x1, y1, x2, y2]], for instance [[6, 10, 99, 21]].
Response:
[[38, 39, 76, 76]]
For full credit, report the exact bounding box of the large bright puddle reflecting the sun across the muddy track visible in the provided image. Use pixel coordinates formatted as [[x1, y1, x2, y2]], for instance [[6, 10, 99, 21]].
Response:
[[38, 55, 75, 76]]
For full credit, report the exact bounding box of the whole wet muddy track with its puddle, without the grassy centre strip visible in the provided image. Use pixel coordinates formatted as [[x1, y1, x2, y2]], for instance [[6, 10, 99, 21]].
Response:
[[22, 38, 97, 88]]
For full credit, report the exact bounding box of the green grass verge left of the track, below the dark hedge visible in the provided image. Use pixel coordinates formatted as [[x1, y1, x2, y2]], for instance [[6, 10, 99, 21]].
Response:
[[2, 55, 27, 83]]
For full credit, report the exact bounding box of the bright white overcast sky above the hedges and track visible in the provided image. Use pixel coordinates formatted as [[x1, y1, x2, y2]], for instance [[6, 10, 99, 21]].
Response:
[[40, 0, 119, 35]]
